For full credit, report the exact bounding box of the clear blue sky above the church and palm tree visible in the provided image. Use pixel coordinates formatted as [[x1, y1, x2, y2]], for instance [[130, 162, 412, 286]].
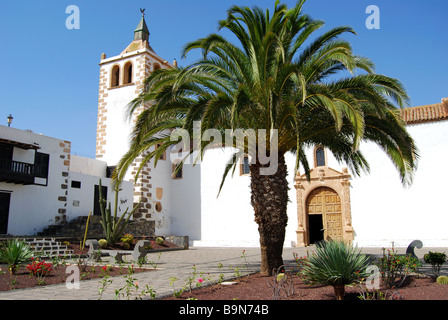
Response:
[[0, 0, 448, 157]]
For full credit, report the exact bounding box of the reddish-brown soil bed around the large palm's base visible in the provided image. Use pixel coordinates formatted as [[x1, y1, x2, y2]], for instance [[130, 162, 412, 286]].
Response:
[[165, 274, 448, 300]]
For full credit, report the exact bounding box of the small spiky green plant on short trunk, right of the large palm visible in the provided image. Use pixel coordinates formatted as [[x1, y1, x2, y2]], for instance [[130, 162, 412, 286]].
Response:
[[302, 241, 369, 300]]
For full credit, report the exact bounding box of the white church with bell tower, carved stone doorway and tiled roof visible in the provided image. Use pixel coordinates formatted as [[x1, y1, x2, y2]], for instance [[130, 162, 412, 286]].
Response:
[[0, 12, 448, 247]]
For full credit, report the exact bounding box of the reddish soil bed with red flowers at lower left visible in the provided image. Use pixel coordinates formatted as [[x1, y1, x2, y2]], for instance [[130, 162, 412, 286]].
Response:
[[0, 261, 152, 291]]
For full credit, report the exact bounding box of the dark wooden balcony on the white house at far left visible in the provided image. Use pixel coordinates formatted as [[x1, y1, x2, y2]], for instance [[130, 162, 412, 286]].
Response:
[[0, 159, 35, 185]]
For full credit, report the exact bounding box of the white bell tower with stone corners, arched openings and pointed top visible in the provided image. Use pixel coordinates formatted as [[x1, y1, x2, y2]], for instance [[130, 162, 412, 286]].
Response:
[[96, 9, 173, 219]]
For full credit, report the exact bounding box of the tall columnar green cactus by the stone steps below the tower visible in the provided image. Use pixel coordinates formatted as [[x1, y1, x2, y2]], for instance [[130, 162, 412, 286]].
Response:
[[99, 179, 140, 245]]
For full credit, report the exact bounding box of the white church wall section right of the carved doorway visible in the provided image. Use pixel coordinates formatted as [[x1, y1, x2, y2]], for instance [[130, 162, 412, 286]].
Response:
[[351, 121, 448, 247]]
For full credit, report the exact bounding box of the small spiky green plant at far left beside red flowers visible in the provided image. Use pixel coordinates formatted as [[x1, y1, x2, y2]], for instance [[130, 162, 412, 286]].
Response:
[[0, 239, 34, 274]]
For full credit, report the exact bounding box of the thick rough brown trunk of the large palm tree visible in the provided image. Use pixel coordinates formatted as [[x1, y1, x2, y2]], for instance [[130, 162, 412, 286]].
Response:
[[250, 154, 288, 276]]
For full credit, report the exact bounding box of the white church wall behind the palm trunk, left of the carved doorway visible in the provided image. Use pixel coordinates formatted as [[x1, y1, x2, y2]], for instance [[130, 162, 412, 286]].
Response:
[[192, 149, 297, 247]]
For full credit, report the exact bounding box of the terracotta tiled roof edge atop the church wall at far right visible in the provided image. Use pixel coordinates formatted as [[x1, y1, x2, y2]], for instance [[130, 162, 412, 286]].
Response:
[[401, 98, 448, 124]]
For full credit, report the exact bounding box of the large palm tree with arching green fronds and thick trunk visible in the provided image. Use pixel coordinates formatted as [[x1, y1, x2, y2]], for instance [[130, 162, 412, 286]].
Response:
[[114, 0, 417, 275]]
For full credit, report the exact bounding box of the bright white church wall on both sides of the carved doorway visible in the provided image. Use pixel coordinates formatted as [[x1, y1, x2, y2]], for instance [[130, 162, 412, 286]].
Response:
[[185, 121, 448, 247]]
